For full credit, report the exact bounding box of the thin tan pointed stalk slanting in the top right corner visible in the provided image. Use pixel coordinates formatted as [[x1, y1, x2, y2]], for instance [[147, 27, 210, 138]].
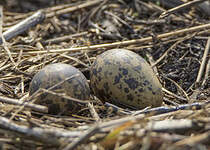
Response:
[[160, 0, 206, 18]]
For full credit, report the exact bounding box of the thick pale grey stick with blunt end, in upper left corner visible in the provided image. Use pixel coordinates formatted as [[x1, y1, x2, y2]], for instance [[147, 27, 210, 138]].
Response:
[[0, 11, 45, 44]]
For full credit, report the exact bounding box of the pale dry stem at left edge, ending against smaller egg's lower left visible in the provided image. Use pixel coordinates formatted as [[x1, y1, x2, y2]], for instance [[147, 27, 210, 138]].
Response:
[[0, 96, 48, 113]]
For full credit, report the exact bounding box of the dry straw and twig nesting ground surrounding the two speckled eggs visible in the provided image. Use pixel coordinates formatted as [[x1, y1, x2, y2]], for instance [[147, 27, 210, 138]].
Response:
[[0, 0, 210, 150]]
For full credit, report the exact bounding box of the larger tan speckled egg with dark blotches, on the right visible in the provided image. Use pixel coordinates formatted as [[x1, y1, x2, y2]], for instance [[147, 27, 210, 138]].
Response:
[[90, 49, 163, 109]]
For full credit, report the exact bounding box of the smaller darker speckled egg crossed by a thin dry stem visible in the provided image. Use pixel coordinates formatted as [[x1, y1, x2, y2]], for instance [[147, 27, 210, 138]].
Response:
[[29, 63, 90, 114]]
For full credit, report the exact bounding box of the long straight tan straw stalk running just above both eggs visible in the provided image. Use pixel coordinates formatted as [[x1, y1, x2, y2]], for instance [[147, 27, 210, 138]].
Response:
[[13, 23, 210, 54]]
